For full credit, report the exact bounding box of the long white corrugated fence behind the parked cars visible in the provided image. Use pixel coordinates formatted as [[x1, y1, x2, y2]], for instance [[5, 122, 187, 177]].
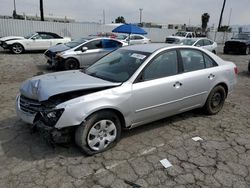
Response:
[[0, 18, 233, 43]]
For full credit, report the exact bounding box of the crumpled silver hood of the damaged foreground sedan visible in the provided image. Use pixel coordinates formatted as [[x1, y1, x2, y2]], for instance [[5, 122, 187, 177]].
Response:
[[20, 70, 121, 101]]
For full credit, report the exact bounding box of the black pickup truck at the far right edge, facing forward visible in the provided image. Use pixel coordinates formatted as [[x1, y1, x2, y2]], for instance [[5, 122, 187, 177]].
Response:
[[224, 33, 250, 55]]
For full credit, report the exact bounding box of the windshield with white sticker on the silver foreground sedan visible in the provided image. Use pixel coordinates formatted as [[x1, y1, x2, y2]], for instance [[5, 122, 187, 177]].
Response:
[[85, 49, 150, 82]]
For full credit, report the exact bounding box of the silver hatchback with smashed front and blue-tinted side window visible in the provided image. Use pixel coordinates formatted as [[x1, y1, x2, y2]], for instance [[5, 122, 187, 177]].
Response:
[[44, 37, 127, 70]]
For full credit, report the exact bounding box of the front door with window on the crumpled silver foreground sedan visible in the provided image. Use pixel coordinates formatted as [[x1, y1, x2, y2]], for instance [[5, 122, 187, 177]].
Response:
[[131, 50, 183, 125]]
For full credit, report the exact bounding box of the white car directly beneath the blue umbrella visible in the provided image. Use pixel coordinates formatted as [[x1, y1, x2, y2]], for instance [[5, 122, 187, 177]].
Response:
[[116, 34, 151, 45]]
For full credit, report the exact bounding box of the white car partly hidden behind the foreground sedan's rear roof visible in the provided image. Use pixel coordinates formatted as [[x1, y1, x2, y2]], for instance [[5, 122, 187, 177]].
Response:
[[180, 38, 217, 54]]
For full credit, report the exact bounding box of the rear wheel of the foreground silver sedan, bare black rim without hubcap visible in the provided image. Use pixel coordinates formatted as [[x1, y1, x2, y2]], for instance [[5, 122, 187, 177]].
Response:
[[204, 85, 226, 115]]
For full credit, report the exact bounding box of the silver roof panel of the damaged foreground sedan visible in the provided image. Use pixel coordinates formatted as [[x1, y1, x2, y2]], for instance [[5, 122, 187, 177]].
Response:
[[123, 43, 179, 53]]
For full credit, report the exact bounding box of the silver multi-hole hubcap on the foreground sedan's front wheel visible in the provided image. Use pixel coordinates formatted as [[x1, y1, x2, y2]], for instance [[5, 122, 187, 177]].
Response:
[[87, 120, 117, 151]]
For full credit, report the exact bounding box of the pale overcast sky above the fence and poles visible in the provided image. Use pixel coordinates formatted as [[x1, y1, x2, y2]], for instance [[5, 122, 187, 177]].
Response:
[[0, 0, 250, 26]]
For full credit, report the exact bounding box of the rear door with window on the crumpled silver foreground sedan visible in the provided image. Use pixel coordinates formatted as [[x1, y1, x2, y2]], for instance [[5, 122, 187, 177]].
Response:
[[176, 49, 217, 111]]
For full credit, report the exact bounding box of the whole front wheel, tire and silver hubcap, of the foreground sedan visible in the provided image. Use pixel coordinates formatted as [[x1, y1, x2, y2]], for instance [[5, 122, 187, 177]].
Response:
[[75, 111, 121, 155]]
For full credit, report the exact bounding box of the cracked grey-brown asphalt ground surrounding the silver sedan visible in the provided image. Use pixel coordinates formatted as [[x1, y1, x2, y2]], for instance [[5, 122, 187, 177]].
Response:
[[0, 46, 250, 188]]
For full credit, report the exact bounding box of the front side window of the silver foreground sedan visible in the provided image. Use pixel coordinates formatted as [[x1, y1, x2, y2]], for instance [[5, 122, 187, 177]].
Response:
[[143, 51, 178, 80]]
